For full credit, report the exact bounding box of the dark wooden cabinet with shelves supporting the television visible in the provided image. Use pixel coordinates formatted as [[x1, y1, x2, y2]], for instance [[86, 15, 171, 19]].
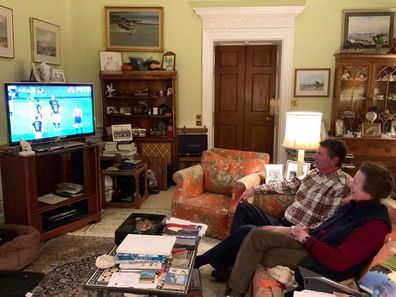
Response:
[[0, 144, 101, 240]]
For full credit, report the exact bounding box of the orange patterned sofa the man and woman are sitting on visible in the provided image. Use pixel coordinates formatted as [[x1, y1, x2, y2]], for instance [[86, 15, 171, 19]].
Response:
[[249, 194, 396, 297]]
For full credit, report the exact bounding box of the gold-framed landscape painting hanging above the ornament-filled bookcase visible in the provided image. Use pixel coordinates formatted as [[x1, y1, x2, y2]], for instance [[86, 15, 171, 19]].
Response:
[[105, 6, 164, 52]]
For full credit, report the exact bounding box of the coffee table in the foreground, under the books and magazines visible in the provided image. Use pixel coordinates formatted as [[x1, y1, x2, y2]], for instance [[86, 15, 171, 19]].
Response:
[[84, 244, 202, 297]]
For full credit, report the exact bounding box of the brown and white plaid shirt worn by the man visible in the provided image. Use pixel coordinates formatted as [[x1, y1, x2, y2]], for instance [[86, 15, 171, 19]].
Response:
[[255, 168, 349, 229]]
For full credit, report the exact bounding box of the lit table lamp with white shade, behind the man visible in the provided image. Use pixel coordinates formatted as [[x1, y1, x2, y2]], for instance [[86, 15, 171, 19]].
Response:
[[282, 112, 322, 176]]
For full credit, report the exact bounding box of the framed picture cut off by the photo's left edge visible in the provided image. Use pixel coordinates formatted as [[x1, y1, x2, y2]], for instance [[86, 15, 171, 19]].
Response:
[[0, 5, 15, 58]]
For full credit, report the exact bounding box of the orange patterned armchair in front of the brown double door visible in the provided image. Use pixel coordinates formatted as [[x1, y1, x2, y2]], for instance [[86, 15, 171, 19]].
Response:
[[172, 148, 269, 239]]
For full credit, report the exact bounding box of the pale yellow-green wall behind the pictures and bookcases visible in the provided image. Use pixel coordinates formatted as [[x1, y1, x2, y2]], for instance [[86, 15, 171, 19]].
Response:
[[0, 0, 396, 144]]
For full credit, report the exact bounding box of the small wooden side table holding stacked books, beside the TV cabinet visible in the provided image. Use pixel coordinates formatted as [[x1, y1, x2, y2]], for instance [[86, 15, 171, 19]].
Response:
[[101, 163, 148, 208]]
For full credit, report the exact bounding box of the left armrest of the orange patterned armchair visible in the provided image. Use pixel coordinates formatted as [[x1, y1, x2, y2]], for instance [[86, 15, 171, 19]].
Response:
[[173, 164, 204, 201]]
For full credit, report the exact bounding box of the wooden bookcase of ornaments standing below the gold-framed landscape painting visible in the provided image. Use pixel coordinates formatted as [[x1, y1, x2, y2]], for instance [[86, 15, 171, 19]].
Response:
[[100, 70, 177, 190]]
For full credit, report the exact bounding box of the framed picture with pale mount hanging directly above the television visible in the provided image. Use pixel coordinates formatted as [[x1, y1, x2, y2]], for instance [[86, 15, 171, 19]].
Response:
[[30, 18, 60, 65]]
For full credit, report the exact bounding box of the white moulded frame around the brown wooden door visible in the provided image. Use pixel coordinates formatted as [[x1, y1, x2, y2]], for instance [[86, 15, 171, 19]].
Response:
[[194, 6, 305, 163]]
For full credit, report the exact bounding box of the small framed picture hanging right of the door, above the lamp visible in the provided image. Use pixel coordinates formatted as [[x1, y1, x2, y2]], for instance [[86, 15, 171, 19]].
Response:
[[294, 68, 331, 97]]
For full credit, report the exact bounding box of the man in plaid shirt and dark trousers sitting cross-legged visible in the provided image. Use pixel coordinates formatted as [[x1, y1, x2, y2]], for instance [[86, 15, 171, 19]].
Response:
[[195, 137, 349, 280]]
